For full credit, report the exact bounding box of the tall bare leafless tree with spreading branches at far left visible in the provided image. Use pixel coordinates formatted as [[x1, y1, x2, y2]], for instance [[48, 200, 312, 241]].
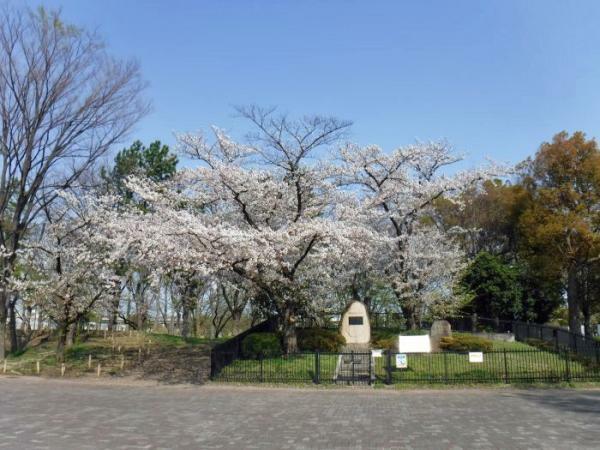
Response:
[[0, 8, 149, 358]]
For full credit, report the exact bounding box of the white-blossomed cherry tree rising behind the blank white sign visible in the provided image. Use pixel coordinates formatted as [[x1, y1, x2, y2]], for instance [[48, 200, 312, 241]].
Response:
[[334, 142, 504, 328]]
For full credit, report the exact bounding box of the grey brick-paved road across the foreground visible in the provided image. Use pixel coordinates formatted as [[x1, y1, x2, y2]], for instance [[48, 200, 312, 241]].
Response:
[[0, 377, 600, 450]]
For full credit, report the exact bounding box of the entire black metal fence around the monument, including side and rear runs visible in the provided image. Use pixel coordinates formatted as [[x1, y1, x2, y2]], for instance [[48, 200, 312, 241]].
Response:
[[211, 314, 600, 383]]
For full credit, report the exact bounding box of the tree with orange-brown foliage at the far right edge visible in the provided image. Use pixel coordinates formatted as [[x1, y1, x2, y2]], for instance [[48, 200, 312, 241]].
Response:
[[519, 132, 600, 335]]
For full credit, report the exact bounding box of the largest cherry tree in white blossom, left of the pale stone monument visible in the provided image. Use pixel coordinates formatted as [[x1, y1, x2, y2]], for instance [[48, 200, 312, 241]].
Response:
[[109, 108, 374, 352]]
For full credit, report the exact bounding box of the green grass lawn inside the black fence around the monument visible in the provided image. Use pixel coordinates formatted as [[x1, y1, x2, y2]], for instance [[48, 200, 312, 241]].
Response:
[[217, 341, 600, 384]]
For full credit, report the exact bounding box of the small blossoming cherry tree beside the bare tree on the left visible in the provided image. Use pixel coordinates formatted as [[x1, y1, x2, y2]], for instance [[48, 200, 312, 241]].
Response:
[[12, 194, 121, 360]]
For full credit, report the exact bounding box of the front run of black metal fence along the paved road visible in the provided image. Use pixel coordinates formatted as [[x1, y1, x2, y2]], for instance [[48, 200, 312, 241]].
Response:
[[213, 349, 600, 384]]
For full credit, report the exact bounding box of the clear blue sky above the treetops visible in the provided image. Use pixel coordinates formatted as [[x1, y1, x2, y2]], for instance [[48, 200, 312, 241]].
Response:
[[27, 0, 600, 167]]
